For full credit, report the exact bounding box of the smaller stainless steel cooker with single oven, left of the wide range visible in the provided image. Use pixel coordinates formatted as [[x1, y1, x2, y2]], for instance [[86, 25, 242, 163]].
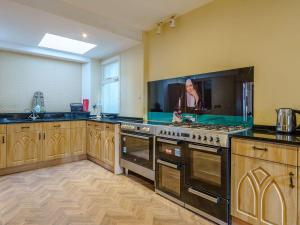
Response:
[[120, 123, 155, 180]]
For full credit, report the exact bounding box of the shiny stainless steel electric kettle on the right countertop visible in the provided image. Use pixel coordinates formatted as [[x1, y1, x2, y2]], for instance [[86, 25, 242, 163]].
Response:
[[276, 108, 300, 133]]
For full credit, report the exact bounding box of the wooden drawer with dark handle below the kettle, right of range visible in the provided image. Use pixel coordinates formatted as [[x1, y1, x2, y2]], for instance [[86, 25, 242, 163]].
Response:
[[231, 138, 297, 166]]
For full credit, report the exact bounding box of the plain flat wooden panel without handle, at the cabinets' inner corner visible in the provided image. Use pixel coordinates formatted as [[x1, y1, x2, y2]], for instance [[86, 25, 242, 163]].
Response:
[[70, 121, 87, 155]]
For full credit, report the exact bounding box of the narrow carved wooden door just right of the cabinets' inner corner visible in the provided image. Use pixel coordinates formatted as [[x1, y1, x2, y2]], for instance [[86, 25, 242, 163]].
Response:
[[87, 127, 101, 159]]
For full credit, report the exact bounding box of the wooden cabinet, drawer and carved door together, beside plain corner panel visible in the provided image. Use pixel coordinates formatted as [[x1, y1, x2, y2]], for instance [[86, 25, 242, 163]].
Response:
[[43, 122, 70, 160]]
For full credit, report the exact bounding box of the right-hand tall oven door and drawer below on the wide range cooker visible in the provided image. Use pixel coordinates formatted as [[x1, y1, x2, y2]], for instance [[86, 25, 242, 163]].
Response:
[[183, 143, 230, 224]]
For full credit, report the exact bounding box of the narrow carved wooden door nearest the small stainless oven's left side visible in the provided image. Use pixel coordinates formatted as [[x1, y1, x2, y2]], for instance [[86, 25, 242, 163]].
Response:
[[101, 126, 115, 167]]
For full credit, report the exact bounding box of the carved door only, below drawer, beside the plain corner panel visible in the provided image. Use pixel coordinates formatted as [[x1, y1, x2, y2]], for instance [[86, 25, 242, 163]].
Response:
[[44, 128, 70, 160]]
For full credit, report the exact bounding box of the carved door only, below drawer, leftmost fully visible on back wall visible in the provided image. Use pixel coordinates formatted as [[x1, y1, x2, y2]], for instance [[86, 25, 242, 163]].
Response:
[[7, 131, 42, 167]]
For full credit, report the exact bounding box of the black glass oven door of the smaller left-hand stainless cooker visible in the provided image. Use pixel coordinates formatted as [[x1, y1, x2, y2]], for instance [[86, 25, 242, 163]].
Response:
[[121, 132, 154, 170]]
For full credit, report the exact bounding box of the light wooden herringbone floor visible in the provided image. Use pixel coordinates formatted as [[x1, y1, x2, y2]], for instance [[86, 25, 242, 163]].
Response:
[[0, 160, 211, 225]]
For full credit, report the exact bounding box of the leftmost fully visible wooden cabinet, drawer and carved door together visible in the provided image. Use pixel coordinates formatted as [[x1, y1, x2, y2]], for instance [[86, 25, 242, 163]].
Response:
[[6, 124, 42, 167]]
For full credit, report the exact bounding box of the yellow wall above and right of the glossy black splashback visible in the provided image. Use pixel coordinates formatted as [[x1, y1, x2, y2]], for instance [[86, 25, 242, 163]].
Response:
[[145, 0, 300, 125]]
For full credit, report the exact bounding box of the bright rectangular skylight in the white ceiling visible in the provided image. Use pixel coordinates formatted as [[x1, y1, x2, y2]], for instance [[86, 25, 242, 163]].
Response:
[[39, 33, 97, 55]]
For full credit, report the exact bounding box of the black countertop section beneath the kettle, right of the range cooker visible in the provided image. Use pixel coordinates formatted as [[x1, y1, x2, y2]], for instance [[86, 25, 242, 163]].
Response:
[[231, 126, 300, 145]]
